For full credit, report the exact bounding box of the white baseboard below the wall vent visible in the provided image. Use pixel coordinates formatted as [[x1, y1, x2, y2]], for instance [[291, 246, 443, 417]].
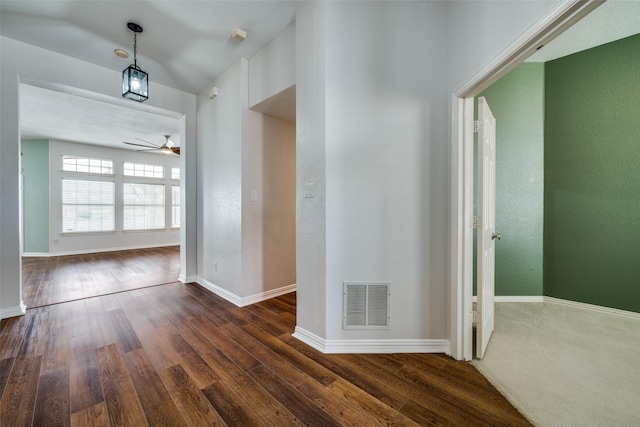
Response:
[[293, 326, 451, 354]]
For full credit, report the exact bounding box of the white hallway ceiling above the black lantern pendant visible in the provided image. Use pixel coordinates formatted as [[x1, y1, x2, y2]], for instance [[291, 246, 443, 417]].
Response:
[[0, 0, 298, 93]]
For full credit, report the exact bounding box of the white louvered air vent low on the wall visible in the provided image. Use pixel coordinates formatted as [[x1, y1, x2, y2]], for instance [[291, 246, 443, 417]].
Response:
[[342, 282, 391, 329]]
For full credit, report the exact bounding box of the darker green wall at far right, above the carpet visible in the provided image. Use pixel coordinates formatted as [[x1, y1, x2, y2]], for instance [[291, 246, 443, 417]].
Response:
[[544, 35, 640, 312]]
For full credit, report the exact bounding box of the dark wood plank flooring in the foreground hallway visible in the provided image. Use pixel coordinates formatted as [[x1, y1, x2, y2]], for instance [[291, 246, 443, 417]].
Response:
[[0, 283, 530, 426]]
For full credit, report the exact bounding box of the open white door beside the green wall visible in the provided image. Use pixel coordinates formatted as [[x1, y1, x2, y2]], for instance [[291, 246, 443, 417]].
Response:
[[476, 97, 500, 358]]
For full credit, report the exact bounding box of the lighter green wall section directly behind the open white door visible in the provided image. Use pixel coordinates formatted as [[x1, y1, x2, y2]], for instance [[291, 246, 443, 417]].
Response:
[[480, 63, 544, 296]]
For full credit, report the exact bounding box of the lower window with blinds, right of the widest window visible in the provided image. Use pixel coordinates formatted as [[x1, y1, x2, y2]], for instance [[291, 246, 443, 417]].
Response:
[[122, 182, 165, 230]]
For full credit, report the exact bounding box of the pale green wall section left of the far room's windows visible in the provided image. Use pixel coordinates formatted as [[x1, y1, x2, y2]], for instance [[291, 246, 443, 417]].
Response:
[[21, 140, 49, 253]]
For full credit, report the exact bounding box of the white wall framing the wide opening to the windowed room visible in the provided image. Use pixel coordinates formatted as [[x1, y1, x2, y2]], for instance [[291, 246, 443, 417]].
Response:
[[0, 37, 196, 317]]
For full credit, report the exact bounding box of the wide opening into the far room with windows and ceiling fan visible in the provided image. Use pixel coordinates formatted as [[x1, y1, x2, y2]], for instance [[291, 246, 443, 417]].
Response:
[[19, 78, 187, 308]]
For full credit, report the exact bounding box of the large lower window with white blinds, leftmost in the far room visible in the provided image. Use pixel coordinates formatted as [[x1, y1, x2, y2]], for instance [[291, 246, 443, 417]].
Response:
[[62, 179, 115, 233]]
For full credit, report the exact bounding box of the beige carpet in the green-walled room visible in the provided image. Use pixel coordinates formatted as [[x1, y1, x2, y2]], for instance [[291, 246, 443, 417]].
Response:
[[473, 302, 640, 427]]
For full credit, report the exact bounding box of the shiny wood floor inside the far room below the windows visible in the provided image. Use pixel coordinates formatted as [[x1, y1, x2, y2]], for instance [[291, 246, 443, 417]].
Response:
[[22, 246, 180, 307]]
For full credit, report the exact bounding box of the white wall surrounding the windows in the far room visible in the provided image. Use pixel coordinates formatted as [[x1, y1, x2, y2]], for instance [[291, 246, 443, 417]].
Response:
[[49, 140, 180, 255]]
